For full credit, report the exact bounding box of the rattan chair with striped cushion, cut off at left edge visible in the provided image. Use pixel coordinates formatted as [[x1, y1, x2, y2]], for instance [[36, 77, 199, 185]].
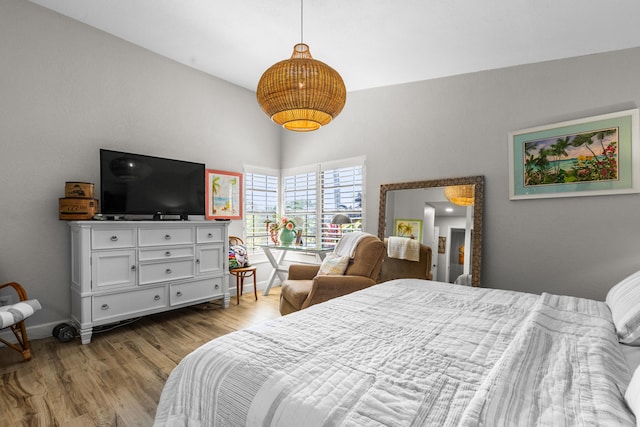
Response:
[[0, 282, 42, 362]]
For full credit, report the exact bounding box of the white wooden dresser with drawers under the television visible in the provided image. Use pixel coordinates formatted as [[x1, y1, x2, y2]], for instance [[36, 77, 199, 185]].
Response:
[[69, 221, 229, 344]]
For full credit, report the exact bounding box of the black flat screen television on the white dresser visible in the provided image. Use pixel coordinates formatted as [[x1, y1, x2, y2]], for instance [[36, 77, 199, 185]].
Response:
[[100, 149, 205, 219]]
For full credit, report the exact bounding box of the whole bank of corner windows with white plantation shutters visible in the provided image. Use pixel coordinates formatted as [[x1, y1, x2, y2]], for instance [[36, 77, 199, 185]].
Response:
[[244, 157, 365, 252]]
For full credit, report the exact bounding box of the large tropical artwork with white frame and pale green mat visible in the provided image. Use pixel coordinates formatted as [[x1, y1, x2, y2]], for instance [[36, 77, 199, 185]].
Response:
[[509, 109, 640, 200]]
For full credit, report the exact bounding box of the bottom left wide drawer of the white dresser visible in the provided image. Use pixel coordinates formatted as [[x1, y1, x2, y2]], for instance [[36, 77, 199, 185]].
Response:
[[91, 286, 168, 322]]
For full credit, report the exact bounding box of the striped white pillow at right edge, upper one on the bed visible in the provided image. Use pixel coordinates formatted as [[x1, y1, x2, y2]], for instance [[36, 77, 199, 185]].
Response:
[[605, 271, 640, 346]]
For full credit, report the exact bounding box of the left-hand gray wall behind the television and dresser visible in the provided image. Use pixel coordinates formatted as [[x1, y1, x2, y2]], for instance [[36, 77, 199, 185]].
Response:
[[0, 0, 280, 331]]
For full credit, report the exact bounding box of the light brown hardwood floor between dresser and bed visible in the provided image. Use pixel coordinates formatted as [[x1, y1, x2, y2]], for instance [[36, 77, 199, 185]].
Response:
[[0, 288, 280, 427]]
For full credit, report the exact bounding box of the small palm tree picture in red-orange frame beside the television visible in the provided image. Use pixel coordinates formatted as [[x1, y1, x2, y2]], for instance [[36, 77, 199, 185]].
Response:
[[205, 169, 242, 219]]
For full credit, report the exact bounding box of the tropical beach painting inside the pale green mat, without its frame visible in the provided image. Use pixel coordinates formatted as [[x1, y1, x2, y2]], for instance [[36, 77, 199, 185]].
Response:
[[523, 127, 619, 187]]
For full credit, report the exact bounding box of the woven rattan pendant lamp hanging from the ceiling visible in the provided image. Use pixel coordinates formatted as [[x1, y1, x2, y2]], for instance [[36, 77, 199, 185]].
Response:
[[256, 2, 347, 132]]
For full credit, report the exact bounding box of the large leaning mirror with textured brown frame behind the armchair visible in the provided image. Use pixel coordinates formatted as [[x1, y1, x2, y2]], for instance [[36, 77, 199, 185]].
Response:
[[378, 176, 484, 286]]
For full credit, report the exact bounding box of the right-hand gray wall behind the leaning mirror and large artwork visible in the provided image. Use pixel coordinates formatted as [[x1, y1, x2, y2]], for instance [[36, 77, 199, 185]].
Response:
[[282, 48, 640, 299]]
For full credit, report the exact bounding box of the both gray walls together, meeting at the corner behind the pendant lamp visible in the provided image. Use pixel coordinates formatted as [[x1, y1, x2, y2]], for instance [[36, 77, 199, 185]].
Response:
[[0, 0, 640, 336]]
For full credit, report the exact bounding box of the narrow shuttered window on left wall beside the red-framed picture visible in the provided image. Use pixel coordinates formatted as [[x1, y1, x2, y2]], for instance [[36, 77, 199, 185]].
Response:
[[244, 171, 278, 252]]
